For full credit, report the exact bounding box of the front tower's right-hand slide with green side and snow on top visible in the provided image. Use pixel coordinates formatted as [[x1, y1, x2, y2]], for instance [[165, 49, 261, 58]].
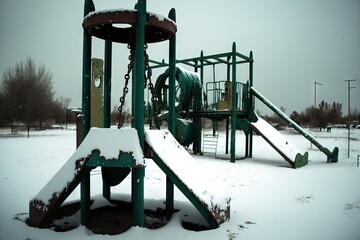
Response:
[[145, 130, 230, 228]]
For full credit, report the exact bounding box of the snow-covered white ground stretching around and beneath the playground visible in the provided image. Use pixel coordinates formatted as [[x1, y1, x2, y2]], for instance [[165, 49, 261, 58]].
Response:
[[0, 126, 360, 240]]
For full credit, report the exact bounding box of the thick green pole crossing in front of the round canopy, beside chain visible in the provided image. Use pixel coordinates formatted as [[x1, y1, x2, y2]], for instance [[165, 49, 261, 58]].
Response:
[[132, 0, 146, 227]]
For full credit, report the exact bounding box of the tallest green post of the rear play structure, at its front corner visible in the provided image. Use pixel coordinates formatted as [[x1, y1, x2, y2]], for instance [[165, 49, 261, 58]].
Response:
[[230, 42, 236, 163]]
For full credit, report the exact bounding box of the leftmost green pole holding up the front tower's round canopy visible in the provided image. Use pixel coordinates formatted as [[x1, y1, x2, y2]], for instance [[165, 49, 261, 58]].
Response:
[[80, 0, 95, 227]]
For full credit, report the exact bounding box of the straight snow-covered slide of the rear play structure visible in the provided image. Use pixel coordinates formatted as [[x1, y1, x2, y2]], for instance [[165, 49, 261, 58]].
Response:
[[250, 116, 308, 168]]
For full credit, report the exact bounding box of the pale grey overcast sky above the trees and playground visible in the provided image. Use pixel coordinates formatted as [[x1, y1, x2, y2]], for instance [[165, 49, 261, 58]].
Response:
[[0, 0, 360, 114]]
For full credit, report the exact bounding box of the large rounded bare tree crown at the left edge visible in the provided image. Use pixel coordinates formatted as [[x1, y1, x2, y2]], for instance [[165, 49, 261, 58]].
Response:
[[0, 58, 54, 125]]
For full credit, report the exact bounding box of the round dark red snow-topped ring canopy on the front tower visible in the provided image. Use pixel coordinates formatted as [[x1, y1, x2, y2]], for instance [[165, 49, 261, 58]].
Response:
[[83, 9, 176, 43]]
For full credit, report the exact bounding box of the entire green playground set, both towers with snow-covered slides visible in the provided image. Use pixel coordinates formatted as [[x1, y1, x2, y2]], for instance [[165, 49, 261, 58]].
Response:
[[28, 0, 338, 234]]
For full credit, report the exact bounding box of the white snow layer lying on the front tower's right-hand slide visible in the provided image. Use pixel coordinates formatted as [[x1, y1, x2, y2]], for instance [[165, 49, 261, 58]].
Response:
[[145, 130, 230, 218]]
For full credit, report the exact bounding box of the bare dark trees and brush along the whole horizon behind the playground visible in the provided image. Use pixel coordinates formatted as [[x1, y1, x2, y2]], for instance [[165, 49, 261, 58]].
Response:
[[0, 58, 360, 128]]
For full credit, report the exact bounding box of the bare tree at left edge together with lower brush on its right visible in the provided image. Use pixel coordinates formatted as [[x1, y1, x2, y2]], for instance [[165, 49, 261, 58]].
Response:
[[0, 58, 71, 128]]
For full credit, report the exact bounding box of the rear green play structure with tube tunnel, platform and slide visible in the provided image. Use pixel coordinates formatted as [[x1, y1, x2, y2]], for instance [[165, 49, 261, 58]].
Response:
[[149, 47, 339, 168]]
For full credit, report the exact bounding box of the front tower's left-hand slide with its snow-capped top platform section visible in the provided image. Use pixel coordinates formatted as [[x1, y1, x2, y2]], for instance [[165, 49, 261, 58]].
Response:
[[29, 128, 145, 227]]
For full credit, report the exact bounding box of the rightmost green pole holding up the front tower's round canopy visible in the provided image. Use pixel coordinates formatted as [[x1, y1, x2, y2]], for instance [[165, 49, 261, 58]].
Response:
[[166, 8, 176, 219]]
